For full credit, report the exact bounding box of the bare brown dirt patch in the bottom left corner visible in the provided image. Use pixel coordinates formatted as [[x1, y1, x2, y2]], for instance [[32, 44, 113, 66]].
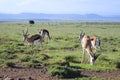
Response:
[[0, 67, 58, 80]]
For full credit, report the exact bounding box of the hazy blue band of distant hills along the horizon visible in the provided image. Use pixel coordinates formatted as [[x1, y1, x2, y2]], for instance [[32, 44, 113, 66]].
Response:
[[0, 13, 120, 22]]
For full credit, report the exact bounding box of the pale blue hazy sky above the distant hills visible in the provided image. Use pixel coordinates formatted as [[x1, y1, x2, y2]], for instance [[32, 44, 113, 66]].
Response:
[[0, 0, 120, 15]]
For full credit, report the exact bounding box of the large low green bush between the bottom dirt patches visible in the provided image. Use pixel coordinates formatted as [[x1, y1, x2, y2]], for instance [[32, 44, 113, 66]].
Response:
[[48, 65, 80, 78]]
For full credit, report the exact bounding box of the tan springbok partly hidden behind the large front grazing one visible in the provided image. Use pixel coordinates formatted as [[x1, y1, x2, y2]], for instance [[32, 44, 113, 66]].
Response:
[[90, 36, 101, 50]]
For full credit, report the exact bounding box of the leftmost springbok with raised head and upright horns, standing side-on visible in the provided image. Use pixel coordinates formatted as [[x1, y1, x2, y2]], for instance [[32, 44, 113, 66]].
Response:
[[23, 29, 42, 48]]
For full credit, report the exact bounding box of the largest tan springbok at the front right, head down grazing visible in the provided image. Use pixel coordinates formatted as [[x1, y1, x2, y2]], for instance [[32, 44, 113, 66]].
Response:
[[79, 32, 94, 65]]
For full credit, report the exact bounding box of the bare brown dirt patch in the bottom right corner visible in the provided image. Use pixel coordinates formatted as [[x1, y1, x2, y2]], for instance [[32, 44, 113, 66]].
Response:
[[81, 69, 120, 80]]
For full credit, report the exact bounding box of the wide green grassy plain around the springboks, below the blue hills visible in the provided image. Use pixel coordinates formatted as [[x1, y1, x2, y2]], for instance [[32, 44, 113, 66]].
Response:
[[0, 22, 120, 78]]
